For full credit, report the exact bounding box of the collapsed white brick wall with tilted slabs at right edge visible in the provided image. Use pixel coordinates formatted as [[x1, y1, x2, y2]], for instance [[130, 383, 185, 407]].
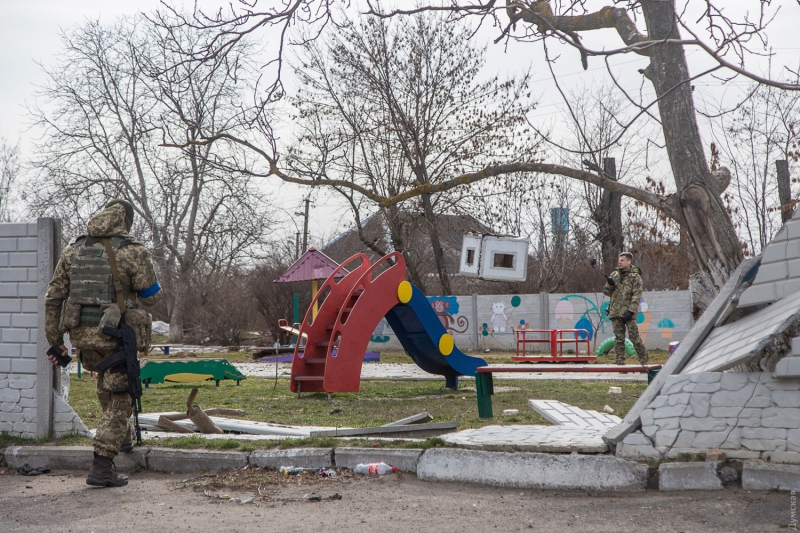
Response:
[[604, 210, 800, 468]]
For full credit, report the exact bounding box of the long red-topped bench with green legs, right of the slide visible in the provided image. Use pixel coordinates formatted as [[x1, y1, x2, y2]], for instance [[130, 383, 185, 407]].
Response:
[[475, 364, 662, 418]]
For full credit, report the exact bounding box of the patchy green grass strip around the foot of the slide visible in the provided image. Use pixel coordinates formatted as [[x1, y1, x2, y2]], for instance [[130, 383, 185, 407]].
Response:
[[65, 374, 646, 429]]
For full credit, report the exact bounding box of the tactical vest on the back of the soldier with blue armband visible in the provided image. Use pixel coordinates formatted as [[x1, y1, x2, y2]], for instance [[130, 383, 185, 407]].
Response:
[[67, 235, 137, 327]]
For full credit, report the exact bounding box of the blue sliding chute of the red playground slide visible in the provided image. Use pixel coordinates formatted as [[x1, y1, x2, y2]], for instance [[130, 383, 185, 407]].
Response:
[[386, 284, 486, 388]]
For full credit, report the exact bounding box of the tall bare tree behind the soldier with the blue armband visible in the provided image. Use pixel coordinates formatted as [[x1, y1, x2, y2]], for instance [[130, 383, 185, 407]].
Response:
[[28, 18, 269, 342]]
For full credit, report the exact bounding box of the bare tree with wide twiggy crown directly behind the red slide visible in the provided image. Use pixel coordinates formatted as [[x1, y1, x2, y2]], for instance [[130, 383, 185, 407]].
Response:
[[287, 15, 533, 294]]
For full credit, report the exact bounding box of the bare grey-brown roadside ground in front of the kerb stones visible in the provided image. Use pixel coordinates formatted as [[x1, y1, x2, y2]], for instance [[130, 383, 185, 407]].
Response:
[[0, 469, 791, 533]]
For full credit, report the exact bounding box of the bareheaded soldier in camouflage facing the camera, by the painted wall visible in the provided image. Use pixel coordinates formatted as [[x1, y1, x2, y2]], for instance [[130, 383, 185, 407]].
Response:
[[603, 252, 648, 365]]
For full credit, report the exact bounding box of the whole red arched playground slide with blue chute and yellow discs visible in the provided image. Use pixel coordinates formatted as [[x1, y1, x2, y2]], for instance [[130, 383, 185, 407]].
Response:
[[291, 252, 486, 393]]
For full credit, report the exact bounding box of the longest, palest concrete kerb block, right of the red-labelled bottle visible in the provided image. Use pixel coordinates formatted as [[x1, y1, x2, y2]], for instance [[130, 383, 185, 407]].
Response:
[[417, 448, 647, 491]]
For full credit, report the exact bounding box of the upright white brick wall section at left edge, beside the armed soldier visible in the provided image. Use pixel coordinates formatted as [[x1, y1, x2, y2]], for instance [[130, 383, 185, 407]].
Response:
[[0, 219, 88, 438]]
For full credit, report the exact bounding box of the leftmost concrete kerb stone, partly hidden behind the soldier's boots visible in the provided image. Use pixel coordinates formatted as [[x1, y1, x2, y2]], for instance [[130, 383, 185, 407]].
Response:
[[5, 446, 149, 471]]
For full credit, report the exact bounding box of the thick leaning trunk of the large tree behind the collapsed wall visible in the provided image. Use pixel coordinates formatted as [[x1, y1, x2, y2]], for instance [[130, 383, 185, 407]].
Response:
[[642, 0, 744, 318]]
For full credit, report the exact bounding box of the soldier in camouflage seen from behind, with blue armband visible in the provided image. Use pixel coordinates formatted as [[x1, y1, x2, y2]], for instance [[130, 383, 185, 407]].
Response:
[[45, 200, 163, 487]]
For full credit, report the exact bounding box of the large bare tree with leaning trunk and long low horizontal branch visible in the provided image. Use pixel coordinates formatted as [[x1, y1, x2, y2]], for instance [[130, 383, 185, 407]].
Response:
[[156, 0, 800, 316]]
